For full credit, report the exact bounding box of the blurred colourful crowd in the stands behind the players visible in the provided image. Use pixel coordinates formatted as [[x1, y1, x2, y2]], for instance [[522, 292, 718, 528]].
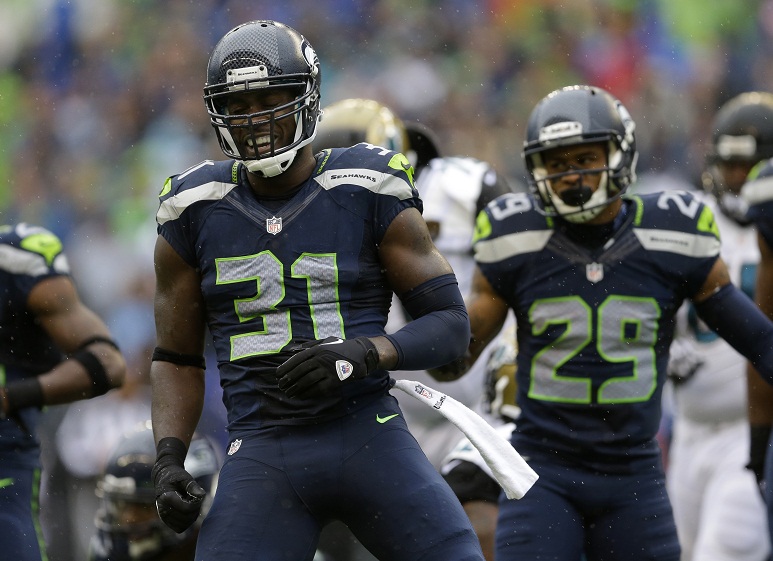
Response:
[[0, 0, 773, 561]]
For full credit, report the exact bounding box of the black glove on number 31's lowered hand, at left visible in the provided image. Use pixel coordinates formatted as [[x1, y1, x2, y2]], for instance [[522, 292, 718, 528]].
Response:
[[151, 436, 207, 534]]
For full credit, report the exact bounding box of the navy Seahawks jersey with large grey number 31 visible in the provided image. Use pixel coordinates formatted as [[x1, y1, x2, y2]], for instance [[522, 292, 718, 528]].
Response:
[[157, 144, 421, 433]]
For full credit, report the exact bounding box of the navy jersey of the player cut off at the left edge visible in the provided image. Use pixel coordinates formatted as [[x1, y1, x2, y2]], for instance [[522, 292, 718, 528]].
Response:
[[0, 224, 70, 450]]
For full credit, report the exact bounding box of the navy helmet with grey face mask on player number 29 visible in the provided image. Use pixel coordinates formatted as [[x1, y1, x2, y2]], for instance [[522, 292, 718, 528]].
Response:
[[523, 85, 638, 223]]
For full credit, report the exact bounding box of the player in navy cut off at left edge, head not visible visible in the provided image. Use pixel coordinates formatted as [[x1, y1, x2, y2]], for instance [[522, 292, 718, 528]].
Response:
[[0, 223, 126, 561]]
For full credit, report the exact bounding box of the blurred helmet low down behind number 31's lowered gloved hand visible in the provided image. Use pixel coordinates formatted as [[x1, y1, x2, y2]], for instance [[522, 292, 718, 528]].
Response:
[[90, 421, 219, 561]]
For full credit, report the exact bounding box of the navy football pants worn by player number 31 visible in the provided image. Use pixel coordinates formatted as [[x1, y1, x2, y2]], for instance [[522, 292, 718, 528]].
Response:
[[196, 394, 483, 561]]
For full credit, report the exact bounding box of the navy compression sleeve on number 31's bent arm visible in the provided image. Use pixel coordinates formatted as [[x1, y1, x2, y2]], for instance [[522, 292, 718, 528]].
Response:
[[387, 274, 470, 370]]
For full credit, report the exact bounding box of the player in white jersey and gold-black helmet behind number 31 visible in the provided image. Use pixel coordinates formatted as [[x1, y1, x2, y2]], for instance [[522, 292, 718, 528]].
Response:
[[314, 98, 512, 468]]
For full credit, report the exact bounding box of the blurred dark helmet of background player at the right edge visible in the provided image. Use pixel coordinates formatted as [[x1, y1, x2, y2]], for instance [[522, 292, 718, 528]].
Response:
[[701, 92, 773, 225]]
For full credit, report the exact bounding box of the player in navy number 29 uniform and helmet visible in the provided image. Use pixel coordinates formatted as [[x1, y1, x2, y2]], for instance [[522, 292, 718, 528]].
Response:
[[434, 85, 773, 561]]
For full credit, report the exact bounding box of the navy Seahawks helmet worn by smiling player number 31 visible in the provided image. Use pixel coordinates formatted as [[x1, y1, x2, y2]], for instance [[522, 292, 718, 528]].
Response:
[[204, 20, 322, 177]]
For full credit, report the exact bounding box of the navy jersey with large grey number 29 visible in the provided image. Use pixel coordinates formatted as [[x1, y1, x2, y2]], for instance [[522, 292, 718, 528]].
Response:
[[475, 191, 720, 471]]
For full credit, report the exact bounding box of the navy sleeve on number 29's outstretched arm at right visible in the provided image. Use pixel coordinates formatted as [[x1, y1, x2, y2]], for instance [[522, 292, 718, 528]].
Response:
[[695, 284, 773, 384]]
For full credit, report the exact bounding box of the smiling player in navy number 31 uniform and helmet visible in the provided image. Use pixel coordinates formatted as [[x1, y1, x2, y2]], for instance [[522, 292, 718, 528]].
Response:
[[151, 21, 482, 561]]
